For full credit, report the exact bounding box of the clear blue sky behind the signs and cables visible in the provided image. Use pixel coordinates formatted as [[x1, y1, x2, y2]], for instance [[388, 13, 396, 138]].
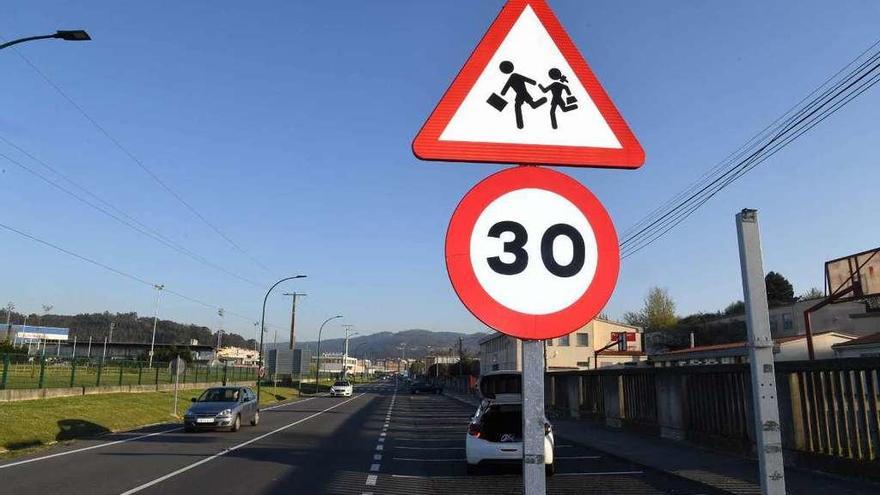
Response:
[[0, 0, 880, 339]]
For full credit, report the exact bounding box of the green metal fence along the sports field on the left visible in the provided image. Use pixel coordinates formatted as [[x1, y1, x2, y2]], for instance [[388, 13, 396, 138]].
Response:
[[0, 354, 257, 390]]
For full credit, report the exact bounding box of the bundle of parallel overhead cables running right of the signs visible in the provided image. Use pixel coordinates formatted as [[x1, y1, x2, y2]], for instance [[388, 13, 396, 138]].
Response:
[[620, 40, 880, 259]]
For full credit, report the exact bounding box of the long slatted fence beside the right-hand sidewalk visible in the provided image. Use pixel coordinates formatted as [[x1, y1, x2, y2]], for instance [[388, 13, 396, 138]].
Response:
[[545, 358, 880, 479]]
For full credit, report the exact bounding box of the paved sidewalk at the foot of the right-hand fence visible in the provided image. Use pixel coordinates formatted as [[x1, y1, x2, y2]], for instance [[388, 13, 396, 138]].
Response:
[[444, 392, 880, 495]]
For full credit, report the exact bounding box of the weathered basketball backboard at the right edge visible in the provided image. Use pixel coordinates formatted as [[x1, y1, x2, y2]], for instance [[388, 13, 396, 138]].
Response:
[[825, 248, 880, 302]]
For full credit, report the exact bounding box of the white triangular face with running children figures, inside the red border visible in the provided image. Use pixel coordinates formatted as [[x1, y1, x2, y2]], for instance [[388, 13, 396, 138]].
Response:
[[439, 6, 622, 149]]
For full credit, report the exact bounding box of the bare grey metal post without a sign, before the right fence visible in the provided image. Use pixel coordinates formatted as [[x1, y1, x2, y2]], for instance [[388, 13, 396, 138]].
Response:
[[736, 209, 785, 495]]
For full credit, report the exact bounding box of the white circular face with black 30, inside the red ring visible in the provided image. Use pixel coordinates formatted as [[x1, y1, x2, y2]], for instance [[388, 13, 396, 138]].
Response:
[[470, 188, 598, 315]]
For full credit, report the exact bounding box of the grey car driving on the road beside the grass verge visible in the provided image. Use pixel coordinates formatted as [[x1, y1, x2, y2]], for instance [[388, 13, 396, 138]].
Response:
[[183, 387, 260, 431]]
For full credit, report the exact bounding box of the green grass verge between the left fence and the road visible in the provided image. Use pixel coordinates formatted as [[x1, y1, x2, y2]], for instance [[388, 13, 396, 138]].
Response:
[[0, 386, 299, 457]]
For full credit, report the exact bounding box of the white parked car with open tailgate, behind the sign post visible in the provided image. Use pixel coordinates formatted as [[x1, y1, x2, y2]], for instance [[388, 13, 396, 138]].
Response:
[[465, 371, 556, 475]]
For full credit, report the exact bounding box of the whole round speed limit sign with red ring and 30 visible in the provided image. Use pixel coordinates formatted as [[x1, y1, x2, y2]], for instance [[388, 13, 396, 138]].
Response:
[[446, 167, 620, 340]]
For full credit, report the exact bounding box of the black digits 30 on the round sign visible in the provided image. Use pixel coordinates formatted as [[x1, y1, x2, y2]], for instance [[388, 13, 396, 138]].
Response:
[[486, 220, 585, 277]]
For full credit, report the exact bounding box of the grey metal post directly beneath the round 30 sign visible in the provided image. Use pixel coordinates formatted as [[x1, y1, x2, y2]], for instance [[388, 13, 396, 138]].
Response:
[[522, 340, 547, 495]]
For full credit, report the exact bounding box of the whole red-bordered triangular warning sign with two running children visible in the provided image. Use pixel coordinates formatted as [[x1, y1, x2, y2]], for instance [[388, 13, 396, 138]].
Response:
[[413, 0, 645, 168]]
